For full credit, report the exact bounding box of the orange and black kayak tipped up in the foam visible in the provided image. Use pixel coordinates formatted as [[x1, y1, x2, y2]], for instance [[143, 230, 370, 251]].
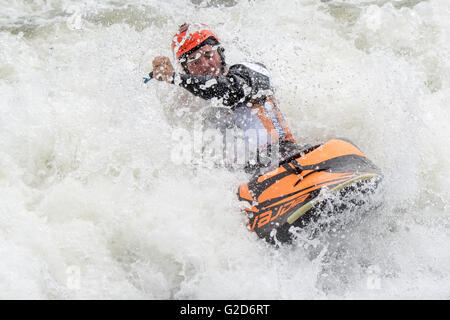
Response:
[[238, 139, 382, 243]]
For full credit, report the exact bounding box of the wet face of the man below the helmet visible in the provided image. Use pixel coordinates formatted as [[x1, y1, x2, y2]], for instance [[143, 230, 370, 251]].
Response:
[[186, 44, 222, 76]]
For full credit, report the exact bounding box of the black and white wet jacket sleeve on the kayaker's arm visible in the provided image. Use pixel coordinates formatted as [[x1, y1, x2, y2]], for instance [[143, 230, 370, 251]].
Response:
[[174, 64, 273, 109]]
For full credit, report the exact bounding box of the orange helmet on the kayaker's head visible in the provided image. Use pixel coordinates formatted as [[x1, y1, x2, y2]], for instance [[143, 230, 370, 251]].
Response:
[[172, 23, 219, 60]]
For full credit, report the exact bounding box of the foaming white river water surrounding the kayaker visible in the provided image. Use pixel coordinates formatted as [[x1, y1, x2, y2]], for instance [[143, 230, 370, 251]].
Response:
[[0, 0, 450, 299]]
